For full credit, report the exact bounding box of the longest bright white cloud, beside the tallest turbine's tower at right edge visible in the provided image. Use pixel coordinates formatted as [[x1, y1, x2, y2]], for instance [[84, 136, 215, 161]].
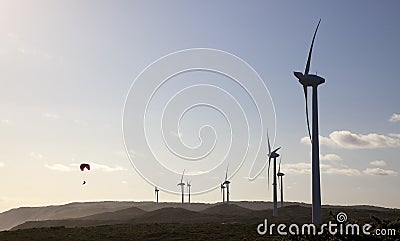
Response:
[[300, 130, 400, 149]]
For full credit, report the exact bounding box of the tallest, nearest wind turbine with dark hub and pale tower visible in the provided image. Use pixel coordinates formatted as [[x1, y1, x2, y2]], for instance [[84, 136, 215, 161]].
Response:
[[294, 19, 325, 224]]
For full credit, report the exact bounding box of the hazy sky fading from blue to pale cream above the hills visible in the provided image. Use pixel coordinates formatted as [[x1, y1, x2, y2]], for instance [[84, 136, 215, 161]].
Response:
[[0, 0, 400, 211]]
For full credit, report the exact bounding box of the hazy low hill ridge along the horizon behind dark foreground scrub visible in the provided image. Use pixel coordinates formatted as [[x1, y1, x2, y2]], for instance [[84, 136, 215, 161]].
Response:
[[0, 201, 400, 231]]
